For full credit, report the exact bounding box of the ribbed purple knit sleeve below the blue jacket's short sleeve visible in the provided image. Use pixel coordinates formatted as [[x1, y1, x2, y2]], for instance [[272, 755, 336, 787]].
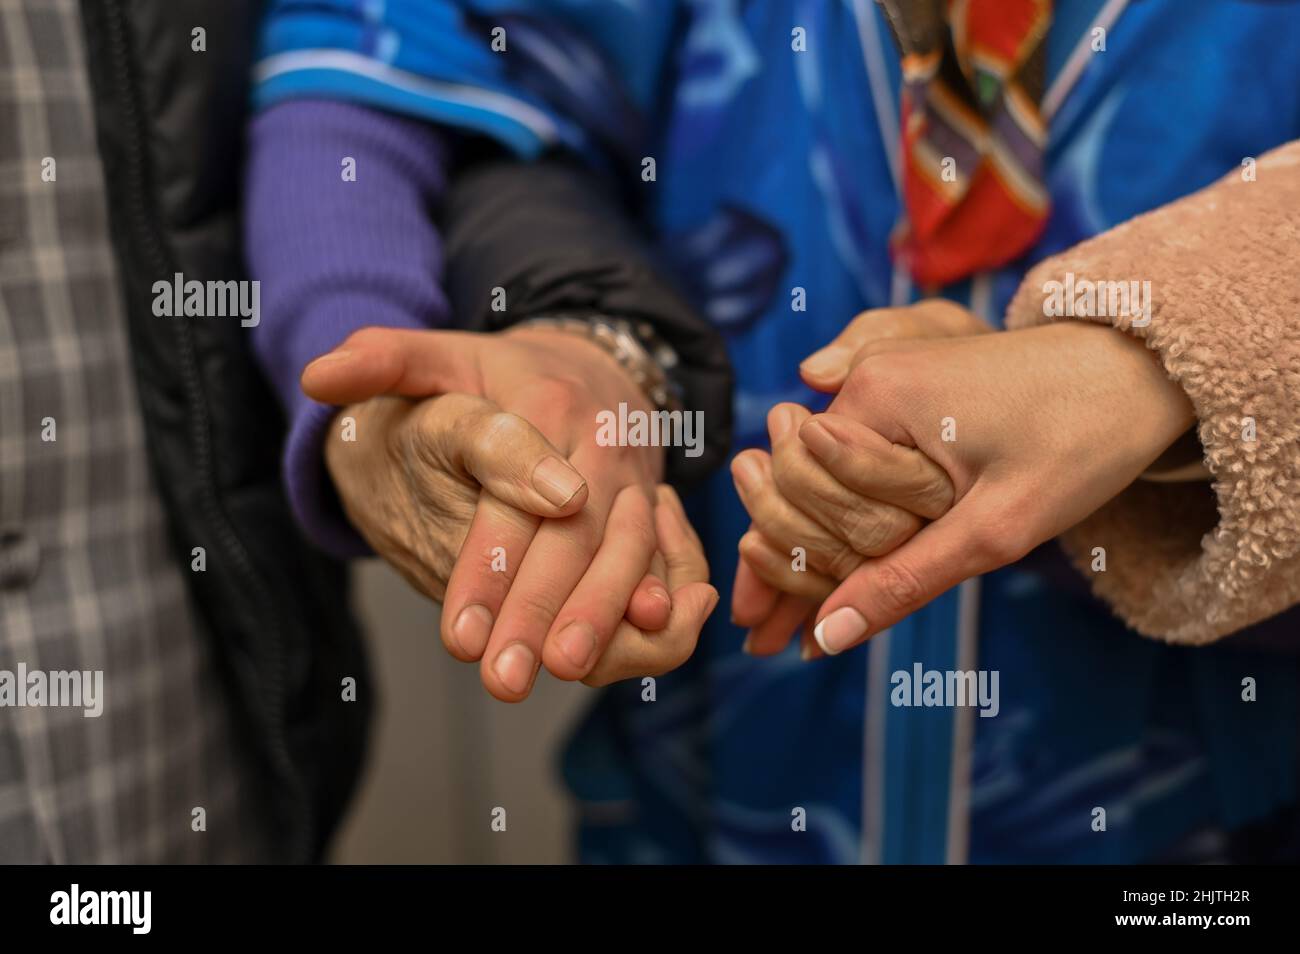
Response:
[[244, 100, 447, 556]]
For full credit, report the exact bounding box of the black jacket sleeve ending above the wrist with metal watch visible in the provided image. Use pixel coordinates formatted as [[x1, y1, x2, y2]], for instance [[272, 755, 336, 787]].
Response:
[[439, 156, 732, 486]]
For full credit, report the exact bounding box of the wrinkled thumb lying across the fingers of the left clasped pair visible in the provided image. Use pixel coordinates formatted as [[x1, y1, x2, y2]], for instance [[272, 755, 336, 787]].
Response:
[[411, 394, 588, 517]]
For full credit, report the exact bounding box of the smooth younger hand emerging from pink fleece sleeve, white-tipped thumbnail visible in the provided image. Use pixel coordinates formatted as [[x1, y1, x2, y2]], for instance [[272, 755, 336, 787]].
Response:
[[800, 322, 1195, 654]]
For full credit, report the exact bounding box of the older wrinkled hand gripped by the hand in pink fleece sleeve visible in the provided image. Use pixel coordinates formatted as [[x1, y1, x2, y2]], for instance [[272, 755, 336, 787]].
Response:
[[732, 299, 992, 658]]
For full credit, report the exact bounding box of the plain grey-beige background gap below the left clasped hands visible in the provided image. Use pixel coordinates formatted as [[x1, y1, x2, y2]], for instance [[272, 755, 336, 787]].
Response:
[[332, 560, 595, 864]]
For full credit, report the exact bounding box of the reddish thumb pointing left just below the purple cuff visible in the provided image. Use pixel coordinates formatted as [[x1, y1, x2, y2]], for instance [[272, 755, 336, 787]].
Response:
[[300, 328, 484, 406]]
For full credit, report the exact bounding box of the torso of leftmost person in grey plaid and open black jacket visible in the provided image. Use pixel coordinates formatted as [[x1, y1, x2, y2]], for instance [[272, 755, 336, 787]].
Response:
[[0, 0, 368, 863]]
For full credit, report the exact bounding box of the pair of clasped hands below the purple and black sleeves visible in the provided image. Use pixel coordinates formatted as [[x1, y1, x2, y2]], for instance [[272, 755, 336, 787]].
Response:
[[303, 329, 712, 701]]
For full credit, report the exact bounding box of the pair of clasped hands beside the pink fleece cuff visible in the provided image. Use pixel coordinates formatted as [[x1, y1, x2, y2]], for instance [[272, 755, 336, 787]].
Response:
[[732, 302, 1195, 656]]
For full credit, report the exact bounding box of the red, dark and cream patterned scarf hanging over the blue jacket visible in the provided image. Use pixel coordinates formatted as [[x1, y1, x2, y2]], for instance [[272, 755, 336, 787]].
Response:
[[880, 0, 1052, 286]]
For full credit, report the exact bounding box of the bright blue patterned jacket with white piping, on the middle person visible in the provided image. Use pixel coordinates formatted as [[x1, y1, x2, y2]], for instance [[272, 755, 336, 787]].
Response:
[[256, 0, 1300, 862]]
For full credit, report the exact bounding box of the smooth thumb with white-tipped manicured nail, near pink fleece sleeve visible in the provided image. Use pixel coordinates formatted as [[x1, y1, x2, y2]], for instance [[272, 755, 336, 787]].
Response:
[[813, 494, 998, 656]]
